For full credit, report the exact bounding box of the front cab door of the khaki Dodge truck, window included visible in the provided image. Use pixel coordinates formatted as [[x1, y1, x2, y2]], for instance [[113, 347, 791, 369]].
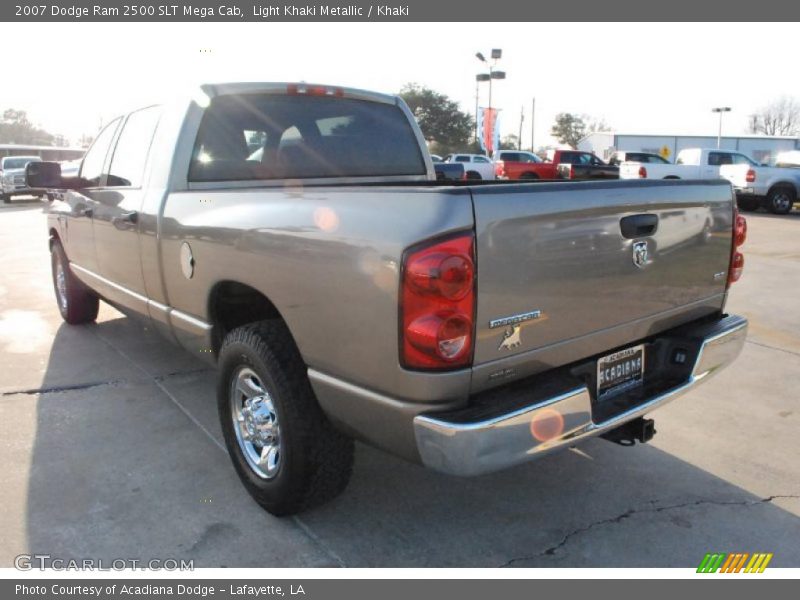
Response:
[[62, 117, 122, 274]]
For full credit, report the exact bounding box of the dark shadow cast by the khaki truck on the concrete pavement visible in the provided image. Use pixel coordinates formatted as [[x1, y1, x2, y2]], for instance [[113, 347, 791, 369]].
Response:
[[17, 308, 800, 567]]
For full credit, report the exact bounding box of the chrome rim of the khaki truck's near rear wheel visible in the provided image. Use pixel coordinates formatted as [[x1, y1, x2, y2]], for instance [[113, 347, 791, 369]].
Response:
[[230, 367, 281, 479]]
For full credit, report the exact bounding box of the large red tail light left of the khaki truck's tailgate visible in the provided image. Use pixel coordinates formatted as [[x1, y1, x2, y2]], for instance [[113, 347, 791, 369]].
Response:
[[400, 233, 475, 370]]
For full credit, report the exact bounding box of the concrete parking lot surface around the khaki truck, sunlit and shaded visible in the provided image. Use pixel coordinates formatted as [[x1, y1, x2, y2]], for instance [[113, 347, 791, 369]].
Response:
[[0, 202, 800, 567]]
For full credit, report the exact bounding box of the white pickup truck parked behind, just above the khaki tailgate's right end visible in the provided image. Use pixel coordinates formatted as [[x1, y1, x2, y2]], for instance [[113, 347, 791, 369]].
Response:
[[619, 148, 758, 179]]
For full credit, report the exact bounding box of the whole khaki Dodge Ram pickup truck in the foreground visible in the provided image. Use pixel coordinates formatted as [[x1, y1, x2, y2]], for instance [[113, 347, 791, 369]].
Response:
[[27, 84, 747, 514]]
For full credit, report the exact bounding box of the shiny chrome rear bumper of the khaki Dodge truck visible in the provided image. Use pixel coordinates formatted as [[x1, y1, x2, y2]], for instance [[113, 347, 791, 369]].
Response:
[[414, 316, 747, 476]]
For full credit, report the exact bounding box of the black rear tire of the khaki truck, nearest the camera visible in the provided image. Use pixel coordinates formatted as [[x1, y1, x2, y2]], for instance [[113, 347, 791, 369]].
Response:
[[217, 320, 353, 516]]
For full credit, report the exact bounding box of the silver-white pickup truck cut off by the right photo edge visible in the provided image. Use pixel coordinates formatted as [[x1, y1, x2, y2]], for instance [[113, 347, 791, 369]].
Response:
[[720, 161, 800, 215]]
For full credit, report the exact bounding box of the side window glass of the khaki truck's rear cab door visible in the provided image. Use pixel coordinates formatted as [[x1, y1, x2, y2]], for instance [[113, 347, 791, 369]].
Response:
[[106, 106, 161, 187]]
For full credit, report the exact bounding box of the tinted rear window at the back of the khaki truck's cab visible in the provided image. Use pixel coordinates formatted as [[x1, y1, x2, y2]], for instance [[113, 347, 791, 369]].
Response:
[[189, 94, 426, 181]]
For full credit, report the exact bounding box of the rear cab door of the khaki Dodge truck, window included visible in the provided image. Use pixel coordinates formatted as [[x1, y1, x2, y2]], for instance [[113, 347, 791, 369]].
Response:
[[94, 106, 161, 313]]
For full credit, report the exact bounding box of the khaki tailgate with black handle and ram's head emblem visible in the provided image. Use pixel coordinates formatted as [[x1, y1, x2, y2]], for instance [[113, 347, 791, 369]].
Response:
[[472, 181, 733, 388]]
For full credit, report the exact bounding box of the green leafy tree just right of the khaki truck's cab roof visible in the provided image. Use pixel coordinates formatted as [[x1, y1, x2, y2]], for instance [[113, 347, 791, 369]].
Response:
[[400, 83, 475, 154]]
